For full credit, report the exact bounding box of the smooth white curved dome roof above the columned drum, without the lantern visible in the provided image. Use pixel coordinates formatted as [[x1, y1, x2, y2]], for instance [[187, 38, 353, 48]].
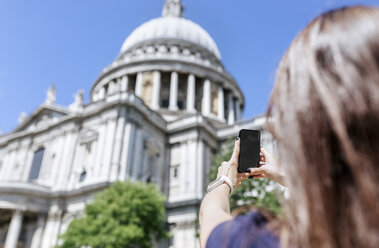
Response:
[[121, 16, 221, 59]]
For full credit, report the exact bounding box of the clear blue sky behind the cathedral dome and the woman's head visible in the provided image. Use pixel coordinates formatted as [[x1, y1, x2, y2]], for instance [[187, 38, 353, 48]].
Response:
[[0, 0, 379, 132]]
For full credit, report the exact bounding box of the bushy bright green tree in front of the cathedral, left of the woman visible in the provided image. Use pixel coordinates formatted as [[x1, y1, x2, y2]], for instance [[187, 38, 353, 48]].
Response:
[[60, 182, 168, 248]]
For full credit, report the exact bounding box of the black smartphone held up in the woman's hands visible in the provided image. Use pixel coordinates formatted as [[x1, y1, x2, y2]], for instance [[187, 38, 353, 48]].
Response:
[[238, 129, 261, 173]]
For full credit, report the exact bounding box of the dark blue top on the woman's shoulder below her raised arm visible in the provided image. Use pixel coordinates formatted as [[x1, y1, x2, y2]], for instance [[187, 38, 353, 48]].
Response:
[[206, 211, 280, 248]]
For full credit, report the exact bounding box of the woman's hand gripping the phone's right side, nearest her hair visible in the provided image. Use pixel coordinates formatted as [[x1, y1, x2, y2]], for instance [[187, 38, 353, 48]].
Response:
[[249, 147, 284, 185]]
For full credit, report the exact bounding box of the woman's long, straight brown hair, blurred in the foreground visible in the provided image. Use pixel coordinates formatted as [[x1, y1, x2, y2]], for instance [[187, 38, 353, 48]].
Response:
[[267, 6, 379, 248]]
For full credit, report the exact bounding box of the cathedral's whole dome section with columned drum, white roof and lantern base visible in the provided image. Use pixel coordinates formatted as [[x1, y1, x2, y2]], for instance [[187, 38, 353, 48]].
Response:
[[91, 0, 244, 124]]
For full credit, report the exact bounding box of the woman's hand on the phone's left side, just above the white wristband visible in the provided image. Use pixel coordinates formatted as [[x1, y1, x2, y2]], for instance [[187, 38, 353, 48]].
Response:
[[217, 138, 250, 189]]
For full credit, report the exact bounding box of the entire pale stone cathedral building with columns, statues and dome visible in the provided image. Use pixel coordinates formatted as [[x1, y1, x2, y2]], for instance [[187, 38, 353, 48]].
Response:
[[0, 0, 272, 248]]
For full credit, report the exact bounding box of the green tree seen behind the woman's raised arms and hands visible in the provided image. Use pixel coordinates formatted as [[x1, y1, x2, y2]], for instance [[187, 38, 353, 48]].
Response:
[[208, 139, 281, 214]]
